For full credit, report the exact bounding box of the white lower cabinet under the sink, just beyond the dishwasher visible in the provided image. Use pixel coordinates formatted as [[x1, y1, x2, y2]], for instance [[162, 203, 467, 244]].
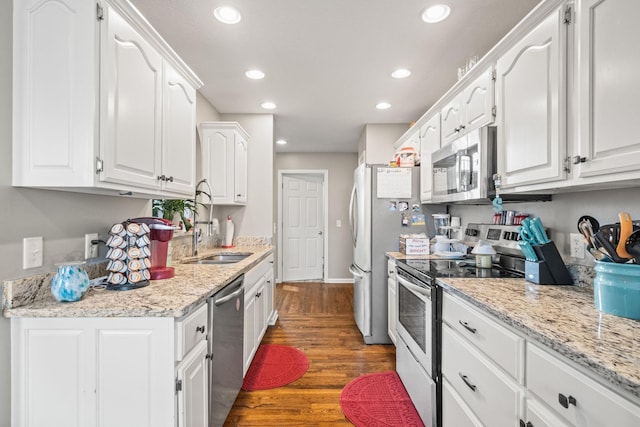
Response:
[[243, 255, 275, 374]]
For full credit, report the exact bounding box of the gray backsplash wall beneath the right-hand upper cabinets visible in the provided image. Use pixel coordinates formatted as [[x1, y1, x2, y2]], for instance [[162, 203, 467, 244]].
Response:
[[449, 188, 640, 265]]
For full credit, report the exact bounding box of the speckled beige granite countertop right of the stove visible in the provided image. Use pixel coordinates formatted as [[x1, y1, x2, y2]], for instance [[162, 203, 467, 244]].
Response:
[[438, 278, 640, 398]]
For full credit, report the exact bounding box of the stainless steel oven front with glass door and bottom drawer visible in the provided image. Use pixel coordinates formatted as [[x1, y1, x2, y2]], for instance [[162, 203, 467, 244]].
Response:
[[396, 262, 441, 427]]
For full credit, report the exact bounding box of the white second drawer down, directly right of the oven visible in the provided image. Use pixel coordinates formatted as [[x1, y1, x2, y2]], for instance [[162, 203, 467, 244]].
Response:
[[442, 325, 524, 426]]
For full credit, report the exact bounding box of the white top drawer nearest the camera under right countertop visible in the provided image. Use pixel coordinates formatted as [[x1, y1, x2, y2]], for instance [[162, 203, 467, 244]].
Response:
[[526, 343, 640, 427]]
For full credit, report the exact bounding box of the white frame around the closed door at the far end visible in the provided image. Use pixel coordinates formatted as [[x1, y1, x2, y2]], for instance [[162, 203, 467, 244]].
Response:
[[276, 169, 329, 283]]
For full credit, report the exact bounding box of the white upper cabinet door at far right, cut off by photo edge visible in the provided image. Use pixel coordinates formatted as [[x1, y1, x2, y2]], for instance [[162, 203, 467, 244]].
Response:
[[577, 0, 640, 178]]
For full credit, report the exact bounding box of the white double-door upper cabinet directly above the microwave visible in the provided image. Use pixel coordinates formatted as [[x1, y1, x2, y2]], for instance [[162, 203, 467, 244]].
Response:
[[440, 68, 495, 145]]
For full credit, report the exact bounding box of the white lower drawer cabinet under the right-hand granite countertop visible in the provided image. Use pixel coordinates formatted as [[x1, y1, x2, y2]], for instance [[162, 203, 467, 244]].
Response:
[[442, 293, 640, 427]]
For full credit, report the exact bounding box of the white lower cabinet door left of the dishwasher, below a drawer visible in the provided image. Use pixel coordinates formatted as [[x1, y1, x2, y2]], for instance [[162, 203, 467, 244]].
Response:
[[176, 341, 209, 427]]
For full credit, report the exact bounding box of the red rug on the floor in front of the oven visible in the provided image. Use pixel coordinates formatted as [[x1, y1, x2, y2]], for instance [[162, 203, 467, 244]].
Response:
[[340, 371, 424, 427]]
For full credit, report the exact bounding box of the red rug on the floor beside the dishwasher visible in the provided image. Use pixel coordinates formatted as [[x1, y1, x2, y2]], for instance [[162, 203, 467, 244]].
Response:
[[242, 344, 309, 390]]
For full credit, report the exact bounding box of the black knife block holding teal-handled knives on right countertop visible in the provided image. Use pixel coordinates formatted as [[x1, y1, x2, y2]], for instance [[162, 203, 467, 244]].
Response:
[[525, 242, 573, 285]]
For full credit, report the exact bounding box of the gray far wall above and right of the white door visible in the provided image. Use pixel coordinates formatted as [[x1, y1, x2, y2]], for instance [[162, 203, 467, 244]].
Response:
[[276, 153, 358, 281]]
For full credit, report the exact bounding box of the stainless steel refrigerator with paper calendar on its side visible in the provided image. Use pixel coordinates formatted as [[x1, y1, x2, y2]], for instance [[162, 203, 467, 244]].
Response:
[[349, 164, 446, 344]]
